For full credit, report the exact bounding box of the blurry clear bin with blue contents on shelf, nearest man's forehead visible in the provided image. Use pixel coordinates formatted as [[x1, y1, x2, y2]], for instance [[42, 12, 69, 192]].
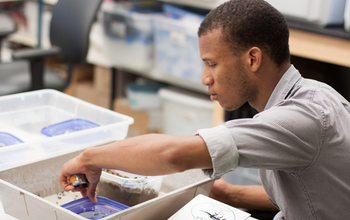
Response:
[[155, 4, 204, 83]]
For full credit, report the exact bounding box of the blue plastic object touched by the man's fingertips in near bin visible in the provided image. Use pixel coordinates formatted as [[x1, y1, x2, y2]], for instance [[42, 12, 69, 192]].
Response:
[[61, 195, 129, 219]]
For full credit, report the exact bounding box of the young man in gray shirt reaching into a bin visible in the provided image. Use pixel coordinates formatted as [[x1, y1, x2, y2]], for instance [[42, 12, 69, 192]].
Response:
[[60, 0, 350, 220]]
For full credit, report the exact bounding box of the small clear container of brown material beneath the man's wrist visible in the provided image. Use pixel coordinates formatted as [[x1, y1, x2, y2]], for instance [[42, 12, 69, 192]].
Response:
[[96, 170, 163, 206]]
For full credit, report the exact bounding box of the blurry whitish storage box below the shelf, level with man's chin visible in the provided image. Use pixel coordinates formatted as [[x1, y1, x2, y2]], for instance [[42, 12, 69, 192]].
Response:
[[159, 88, 214, 136]]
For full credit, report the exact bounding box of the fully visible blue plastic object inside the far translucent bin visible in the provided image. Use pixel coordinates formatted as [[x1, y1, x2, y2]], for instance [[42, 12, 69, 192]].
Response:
[[41, 118, 99, 137]]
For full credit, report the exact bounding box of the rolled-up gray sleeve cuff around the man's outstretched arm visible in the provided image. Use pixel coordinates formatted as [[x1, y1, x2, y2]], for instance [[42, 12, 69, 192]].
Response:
[[197, 125, 239, 179]]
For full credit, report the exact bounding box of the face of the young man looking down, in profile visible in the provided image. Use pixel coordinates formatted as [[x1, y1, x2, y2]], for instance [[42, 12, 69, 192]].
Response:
[[199, 29, 253, 111]]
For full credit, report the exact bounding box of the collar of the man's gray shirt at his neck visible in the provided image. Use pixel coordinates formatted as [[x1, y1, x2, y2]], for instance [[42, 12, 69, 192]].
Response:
[[264, 65, 301, 110]]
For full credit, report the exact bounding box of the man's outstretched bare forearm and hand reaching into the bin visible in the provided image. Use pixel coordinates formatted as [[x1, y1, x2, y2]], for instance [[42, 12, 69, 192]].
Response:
[[60, 134, 212, 201]]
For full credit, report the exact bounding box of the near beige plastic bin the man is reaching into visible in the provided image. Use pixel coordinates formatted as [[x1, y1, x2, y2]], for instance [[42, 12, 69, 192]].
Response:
[[0, 151, 213, 220]]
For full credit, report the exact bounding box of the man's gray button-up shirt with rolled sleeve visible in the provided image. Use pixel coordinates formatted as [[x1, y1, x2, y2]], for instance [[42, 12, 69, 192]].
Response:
[[198, 66, 350, 220]]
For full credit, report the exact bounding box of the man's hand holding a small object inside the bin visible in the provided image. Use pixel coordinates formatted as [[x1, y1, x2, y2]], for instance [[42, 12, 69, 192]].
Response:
[[59, 151, 102, 202]]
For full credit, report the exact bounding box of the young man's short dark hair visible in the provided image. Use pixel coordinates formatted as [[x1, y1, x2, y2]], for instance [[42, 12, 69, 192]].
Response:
[[198, 0, 290, 66]]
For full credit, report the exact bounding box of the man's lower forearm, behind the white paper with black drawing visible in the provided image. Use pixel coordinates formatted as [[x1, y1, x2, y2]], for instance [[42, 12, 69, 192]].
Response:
[[209, 179, 278, 211]]
